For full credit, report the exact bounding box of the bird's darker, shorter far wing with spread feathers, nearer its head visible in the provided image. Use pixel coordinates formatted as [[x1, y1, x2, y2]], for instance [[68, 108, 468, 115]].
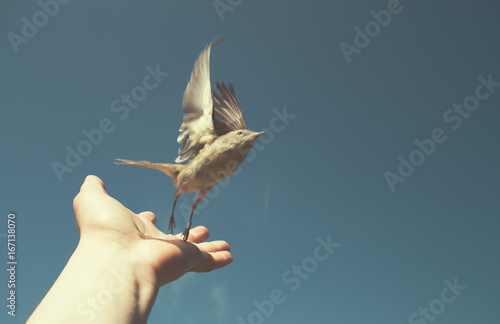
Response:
[[212, 82, 247, 136]]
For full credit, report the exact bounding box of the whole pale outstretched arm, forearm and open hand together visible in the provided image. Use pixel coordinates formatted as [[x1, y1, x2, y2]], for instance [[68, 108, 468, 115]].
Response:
[[27, 176, 232, 323]]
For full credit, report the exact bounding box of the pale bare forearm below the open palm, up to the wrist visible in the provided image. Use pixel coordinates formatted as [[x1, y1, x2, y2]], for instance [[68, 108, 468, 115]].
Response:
[[28, 239, 158, 323]]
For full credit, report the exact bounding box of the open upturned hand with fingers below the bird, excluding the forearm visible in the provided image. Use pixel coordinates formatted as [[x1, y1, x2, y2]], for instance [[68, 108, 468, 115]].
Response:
[[73, 176, 232, 287]]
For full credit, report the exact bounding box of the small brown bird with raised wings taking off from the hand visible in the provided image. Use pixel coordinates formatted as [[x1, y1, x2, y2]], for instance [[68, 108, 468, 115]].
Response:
[[115, 37, 264, 241]]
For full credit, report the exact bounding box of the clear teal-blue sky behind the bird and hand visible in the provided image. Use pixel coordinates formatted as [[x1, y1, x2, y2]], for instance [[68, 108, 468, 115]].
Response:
[[0, 0, 500, 324]]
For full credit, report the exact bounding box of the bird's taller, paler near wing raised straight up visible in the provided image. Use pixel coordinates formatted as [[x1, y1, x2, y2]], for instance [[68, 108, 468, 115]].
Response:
[[175, 37, 223, 162]]
